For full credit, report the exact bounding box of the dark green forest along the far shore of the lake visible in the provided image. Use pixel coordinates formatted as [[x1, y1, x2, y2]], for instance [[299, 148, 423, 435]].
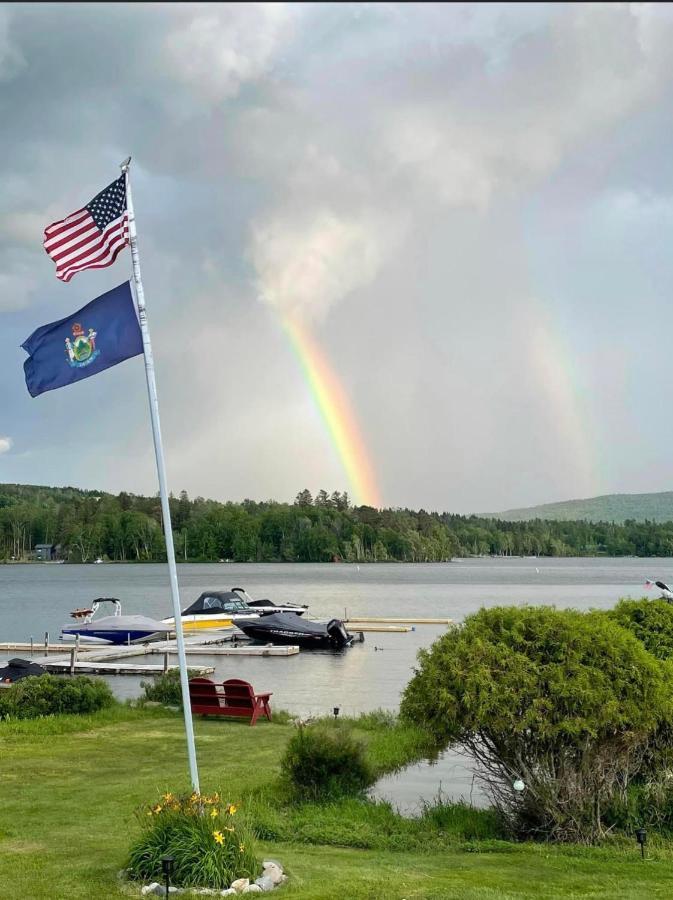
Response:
[[0, 484, 673, 562]]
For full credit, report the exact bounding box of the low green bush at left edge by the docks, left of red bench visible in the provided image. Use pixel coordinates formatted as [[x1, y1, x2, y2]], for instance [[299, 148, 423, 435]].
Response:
[[0, 675, 115, 719]]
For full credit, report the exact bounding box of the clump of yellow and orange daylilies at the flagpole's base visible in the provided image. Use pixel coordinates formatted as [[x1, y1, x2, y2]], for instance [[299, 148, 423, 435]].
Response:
[[127, 793, 262, 890]]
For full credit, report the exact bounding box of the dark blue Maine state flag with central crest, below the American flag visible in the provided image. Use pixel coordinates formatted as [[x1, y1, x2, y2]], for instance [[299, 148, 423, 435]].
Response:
[[21, 281, 143, 397]]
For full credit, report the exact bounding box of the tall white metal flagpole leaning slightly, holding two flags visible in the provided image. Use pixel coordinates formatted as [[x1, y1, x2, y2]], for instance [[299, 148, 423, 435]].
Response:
[[121, 157, 200, 794]]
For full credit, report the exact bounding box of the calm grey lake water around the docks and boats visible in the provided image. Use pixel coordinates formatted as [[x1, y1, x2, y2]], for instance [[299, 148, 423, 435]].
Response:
[[0, 558, 660, 810]]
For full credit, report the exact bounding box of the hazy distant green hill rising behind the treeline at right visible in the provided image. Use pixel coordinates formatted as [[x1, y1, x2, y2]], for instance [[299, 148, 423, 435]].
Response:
[[483, 491, 673, 523]]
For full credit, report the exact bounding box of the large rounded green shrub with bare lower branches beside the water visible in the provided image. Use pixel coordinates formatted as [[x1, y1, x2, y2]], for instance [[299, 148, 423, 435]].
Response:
[[401, 607, 671, 840]]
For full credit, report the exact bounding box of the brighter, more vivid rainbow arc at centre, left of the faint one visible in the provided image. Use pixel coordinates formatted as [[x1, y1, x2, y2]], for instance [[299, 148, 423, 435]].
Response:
[[283, 318, 383, 507]]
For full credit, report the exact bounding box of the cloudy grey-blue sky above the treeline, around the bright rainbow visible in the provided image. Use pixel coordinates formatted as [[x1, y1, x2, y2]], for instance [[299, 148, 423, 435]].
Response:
[[0, 3, 673, 512]]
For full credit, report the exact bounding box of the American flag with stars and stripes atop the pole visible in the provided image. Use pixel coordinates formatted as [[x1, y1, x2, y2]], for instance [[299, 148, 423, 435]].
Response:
[[44, 175, 129, 281]]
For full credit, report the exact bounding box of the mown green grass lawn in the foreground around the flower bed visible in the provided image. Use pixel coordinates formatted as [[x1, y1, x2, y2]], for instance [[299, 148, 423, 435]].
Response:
[[0, 708, 673, 900]]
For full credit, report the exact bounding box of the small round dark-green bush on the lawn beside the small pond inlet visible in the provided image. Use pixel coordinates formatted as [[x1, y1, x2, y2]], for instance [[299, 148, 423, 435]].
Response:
[[281, 722, 376, 800]]
